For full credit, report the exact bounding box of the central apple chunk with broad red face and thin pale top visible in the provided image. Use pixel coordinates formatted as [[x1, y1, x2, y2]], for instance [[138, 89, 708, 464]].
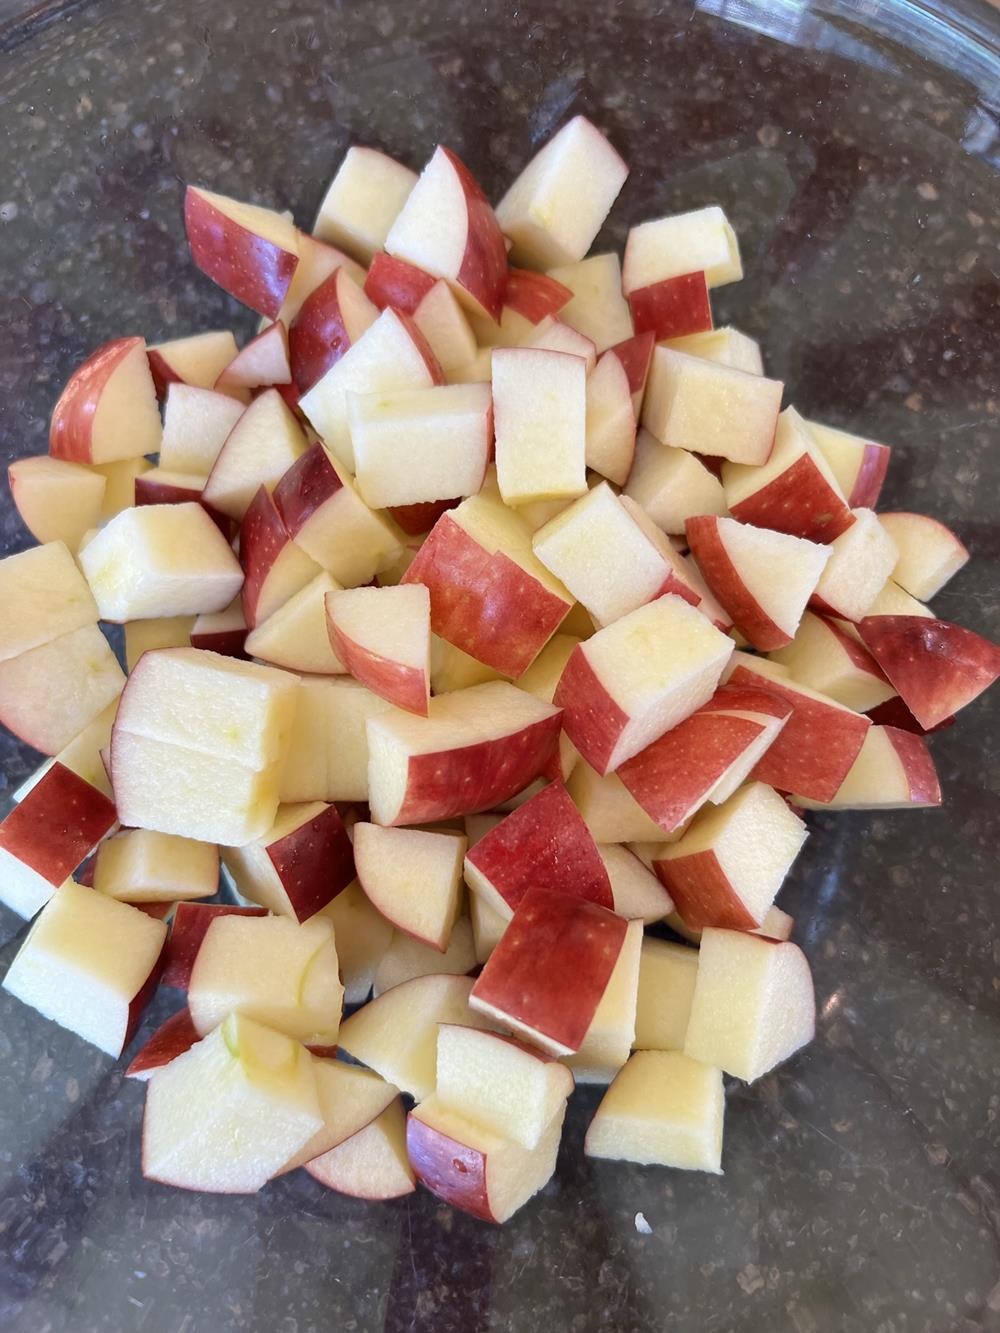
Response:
[[403, 495, 573, 677]]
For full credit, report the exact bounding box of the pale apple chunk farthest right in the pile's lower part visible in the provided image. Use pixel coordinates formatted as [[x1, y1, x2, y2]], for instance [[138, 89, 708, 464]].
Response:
[[684, 928, 816, 1082]]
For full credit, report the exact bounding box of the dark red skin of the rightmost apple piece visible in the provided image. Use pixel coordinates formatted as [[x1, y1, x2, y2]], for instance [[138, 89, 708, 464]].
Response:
[[857, 616, 1000, 730]]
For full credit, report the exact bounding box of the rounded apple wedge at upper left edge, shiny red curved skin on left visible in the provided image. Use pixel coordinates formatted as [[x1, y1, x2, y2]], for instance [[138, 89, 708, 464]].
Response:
[[48, 337, 163, 463]]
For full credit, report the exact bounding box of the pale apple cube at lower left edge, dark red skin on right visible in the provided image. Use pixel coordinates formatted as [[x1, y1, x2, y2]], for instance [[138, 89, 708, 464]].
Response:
[[3, 880, 167, 1058]]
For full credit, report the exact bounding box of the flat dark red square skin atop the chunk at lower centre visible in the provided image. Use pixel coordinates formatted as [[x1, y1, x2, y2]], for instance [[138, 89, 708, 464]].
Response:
[[471, 888, 628, 1050]]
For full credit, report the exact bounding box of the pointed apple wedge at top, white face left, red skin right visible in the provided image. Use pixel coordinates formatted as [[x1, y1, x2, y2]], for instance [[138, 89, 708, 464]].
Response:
[[385, 145, 507, 320]]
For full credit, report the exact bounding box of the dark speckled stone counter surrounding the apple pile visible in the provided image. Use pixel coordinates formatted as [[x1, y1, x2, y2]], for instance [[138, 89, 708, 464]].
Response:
[[0, 0, 1000, 1333]]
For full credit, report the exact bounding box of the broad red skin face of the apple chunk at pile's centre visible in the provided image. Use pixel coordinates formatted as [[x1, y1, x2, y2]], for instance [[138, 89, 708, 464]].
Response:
[[401, 513, 569, 678]]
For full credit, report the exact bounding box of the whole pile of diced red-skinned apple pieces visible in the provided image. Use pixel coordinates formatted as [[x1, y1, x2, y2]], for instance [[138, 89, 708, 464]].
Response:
[[0, 117, 1000, 1221]]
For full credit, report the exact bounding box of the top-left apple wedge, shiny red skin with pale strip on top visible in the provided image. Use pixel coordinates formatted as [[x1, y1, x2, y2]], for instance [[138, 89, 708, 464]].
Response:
[[184, 185, 299, 317]]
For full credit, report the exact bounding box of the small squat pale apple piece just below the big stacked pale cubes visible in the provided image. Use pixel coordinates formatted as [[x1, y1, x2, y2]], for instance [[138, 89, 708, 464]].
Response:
[[93, 829, 219, 905]]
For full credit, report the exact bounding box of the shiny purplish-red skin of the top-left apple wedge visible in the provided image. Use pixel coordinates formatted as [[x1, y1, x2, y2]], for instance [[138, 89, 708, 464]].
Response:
[[184, 185, 299, 320]]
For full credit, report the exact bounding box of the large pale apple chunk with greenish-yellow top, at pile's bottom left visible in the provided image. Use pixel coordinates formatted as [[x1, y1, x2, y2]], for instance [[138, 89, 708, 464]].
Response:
[[143, 1013, 323, 1194]]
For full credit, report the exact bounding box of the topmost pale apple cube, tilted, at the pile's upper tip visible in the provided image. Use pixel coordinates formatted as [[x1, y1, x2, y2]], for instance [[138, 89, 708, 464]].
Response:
[[496, 116, 628, 268]]
